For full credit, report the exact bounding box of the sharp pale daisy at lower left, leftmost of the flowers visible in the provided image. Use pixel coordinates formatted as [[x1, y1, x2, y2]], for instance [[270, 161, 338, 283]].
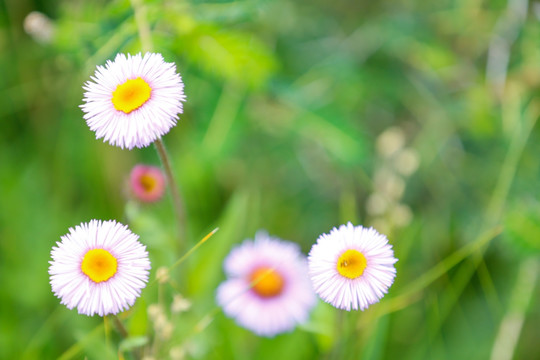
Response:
[[49, 220, 150, 316]]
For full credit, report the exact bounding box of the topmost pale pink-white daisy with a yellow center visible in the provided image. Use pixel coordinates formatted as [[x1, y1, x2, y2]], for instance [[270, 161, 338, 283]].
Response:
[[81, 53, 186, 150]]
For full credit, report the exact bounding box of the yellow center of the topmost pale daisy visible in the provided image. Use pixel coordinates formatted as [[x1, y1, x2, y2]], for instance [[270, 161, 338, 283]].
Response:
[[112, 77, 152, 114]]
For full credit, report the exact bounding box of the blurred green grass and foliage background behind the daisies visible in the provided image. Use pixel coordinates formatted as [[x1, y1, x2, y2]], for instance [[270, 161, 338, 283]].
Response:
[[0, 0, 540, 360]]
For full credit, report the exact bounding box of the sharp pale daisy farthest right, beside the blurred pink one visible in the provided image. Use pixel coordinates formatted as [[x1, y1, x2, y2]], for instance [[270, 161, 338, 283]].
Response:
[[308, 222, 397, 311]]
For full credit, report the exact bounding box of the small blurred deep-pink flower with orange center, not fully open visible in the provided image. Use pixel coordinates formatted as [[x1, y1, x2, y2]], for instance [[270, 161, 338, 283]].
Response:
[[129, 165, 165, 202]]
